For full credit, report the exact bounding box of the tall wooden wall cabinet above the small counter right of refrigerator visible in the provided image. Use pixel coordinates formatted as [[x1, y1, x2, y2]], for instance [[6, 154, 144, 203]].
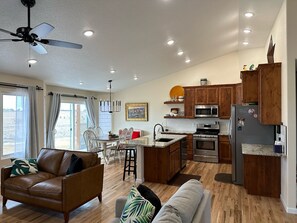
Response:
[[257, 63, 281, 125]]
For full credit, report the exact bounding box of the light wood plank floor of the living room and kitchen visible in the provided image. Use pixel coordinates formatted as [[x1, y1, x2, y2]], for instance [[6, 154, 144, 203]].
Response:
[[0, 161, 297, 223]]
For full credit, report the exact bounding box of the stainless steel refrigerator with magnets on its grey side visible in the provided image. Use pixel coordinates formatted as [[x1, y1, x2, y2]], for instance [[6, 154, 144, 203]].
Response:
[[230, 105, 275, 185]]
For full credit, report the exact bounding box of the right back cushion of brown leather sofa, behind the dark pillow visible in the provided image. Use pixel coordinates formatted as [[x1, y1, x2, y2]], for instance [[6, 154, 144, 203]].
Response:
[[58, 151, 98, 176]]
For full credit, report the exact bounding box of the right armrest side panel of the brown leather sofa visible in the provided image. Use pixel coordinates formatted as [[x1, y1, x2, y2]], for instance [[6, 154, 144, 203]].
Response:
[[62, 164, 104, 212]]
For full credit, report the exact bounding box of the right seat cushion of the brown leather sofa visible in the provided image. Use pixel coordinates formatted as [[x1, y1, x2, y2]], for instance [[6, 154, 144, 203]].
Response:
[[29, 176, 63, 200]]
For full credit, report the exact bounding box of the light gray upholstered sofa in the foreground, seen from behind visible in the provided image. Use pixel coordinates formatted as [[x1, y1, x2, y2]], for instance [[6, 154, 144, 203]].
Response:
[[112, 179, 211, 223]]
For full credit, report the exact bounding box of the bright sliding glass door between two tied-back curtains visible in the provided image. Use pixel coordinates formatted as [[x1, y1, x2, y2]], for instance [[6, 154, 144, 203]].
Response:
[[55, 101, 89, 150]]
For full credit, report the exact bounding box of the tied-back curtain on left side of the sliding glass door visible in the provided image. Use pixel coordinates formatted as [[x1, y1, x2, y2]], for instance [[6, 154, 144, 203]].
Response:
[[46, 93, 61, 148]]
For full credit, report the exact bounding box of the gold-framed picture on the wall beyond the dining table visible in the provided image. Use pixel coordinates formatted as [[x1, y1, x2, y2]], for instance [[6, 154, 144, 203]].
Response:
[[125, 103, 148, 121]]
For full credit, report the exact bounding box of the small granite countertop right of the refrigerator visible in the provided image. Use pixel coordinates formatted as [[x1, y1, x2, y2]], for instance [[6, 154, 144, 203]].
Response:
[[242, 144, 282, 156]]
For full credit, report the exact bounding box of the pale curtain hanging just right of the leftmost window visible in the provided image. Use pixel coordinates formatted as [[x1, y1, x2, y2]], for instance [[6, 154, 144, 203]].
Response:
[[25, 86, 39, 158]]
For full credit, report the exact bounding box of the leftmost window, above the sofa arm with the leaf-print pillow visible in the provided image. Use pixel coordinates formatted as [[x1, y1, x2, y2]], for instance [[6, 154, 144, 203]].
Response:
[[0, 89, 28, 159]]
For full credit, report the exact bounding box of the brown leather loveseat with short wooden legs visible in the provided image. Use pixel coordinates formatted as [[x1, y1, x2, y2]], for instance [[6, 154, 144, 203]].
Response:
[[1, 148, 104, 222]]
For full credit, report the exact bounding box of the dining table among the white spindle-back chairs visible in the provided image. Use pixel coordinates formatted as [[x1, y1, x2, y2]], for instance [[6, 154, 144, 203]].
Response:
[[93, 135, 119, 164]]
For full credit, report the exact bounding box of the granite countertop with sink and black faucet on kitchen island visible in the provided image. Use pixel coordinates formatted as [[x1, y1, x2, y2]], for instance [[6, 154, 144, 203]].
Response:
[[123, 134, 187, 148]]
